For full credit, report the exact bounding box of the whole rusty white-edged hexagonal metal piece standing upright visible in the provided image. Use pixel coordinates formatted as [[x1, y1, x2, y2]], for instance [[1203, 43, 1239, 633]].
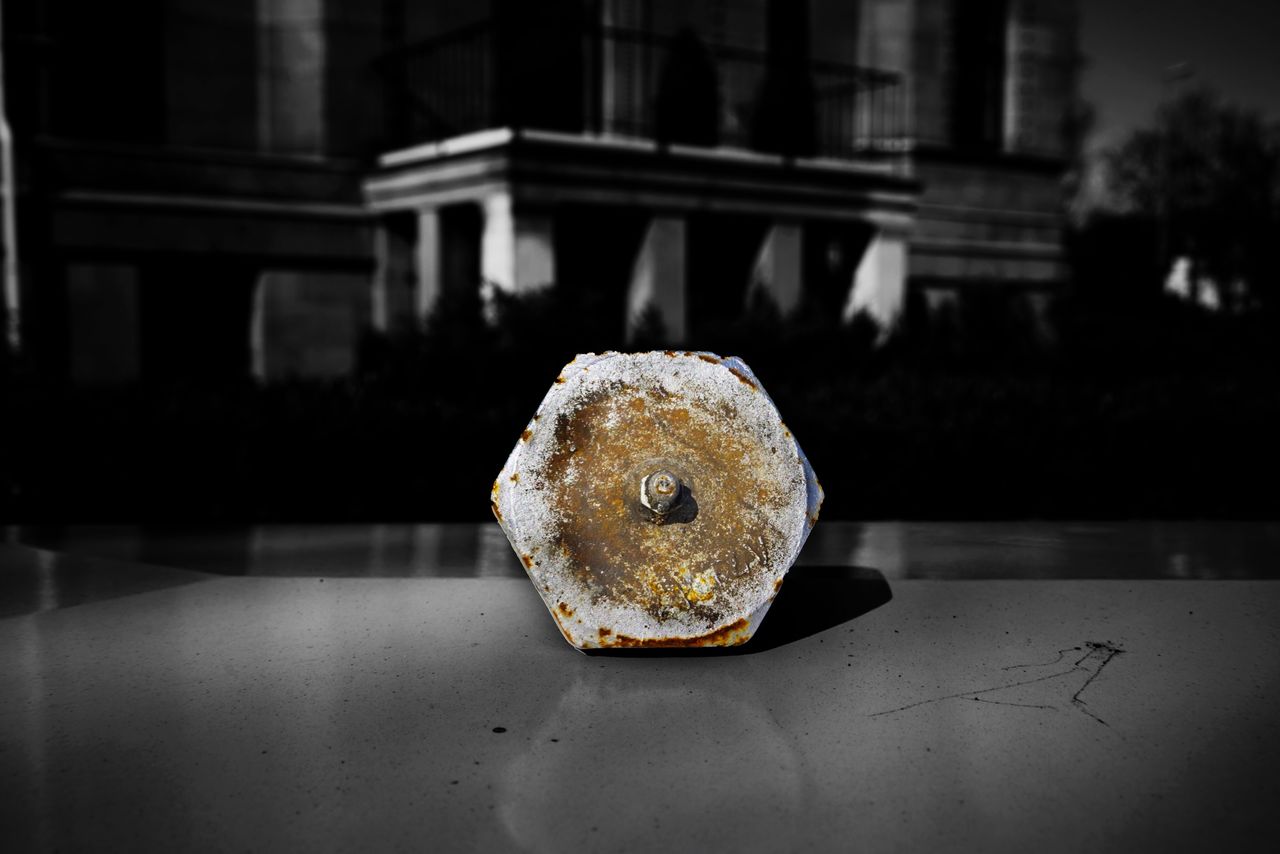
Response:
[[492, 351, 822, 649]]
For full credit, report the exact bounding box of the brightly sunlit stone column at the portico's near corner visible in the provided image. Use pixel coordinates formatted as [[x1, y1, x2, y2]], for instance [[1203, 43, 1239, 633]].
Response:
[[480, 192, 556, 293]]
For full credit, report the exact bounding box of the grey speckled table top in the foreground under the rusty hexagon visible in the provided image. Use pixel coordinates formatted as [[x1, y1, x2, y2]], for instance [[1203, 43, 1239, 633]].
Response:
[[0, 530, 1280, 851]]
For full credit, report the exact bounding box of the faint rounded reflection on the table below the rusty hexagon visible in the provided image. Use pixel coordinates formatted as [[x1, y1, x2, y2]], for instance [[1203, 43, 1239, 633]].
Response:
[[498, 662, 805, 853]]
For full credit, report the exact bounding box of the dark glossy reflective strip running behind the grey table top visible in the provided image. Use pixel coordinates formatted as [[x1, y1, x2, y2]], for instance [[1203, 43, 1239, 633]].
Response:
[[10, 520, 1280, 594]]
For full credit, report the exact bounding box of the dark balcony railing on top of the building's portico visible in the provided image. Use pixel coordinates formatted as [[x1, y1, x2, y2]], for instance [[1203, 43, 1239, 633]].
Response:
[[380, 23, 909, 159]]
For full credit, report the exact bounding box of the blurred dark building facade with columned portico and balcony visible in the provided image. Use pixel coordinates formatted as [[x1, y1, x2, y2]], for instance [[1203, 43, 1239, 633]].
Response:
[[4, 0, 1078, 382]]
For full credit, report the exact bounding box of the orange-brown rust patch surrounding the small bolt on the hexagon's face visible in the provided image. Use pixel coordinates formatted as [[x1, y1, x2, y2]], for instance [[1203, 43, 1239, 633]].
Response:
[[542, 388, 791, 624]]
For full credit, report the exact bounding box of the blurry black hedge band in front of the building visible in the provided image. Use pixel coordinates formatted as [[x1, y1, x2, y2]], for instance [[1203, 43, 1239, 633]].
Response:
[[0, 291, 1280, 524]]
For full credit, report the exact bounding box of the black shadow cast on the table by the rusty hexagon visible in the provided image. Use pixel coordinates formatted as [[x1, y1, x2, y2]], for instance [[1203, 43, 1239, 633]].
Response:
[[586, 566, 893, 658]]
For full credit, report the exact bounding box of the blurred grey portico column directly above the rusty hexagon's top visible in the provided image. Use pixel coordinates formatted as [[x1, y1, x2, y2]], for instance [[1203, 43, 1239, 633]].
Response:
[[627, 216, 689, 343]]
